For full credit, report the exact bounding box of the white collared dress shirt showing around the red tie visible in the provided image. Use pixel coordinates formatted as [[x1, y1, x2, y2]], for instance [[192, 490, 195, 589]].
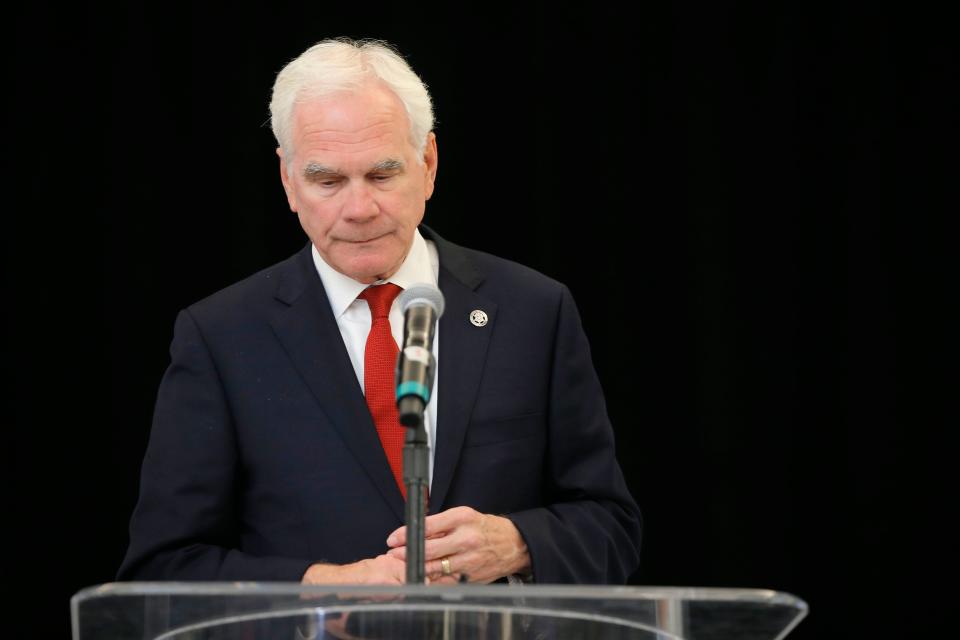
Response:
[[311, 230, 440, 485]]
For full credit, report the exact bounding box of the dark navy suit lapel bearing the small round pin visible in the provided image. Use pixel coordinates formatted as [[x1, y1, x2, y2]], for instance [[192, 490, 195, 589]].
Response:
[[421, 227, 497, 514]]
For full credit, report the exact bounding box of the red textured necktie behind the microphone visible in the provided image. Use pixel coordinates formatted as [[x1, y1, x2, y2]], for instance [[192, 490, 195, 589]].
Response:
[[357, 283, 407, 499]]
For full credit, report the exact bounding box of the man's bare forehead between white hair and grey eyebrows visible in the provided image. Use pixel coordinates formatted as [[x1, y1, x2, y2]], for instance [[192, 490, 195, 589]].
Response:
[[293, 85, 410, 160]]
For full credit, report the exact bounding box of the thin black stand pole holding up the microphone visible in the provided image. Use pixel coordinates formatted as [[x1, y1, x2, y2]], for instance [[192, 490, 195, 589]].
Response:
[[400, 397, 430, 584]]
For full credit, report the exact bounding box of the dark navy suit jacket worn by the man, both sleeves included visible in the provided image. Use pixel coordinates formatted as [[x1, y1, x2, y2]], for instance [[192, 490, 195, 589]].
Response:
[[118, 227, 641, 583]]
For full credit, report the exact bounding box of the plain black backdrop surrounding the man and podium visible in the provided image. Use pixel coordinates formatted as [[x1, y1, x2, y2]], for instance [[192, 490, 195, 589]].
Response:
[[4, 2, 958, 639]]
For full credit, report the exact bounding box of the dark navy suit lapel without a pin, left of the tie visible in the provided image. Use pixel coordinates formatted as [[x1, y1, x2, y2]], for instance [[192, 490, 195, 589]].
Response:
[[271, 244, 406, 521]]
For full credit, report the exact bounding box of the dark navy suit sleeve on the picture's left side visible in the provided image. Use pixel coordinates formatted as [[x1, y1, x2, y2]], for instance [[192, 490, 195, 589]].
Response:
[[117, 310, 311, 582]]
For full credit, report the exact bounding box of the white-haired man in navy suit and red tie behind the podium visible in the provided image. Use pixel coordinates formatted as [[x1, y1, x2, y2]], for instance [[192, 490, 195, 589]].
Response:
[[119, 40, 640, 584]]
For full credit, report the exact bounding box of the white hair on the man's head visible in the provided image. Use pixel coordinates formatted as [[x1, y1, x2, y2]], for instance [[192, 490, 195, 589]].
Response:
[[270, 38, 433, 162]]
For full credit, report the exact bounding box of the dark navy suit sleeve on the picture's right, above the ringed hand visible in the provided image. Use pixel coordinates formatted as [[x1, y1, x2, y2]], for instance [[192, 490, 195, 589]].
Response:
[[508, 287, 641, 584]]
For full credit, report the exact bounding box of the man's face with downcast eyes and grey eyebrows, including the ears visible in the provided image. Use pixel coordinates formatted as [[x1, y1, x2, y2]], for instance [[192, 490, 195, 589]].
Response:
[[278, 84, 437, 283]]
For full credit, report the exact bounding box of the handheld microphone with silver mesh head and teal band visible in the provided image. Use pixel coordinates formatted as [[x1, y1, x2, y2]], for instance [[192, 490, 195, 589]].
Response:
[[396, 283, 443, 428]]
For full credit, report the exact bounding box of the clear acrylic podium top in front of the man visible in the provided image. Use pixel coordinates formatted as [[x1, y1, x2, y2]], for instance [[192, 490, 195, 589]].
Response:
[[71, 582, 807, 640]]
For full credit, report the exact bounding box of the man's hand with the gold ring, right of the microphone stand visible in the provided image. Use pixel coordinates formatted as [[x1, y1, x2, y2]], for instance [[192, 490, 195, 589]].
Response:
[[387, 507, 530, 584]]
